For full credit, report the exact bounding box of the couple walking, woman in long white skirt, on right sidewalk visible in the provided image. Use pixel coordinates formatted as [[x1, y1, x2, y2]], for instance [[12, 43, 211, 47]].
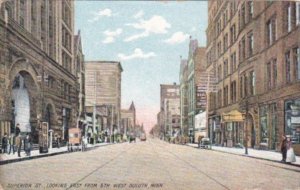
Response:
[[281, 135, 296, 163]]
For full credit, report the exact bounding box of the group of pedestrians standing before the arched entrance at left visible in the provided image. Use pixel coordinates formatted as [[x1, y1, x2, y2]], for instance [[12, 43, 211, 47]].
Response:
[[1, 124, 32, 157]]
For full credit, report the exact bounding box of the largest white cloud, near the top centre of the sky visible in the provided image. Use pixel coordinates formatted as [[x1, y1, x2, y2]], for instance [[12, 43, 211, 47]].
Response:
[[124, 15, 171, 42]]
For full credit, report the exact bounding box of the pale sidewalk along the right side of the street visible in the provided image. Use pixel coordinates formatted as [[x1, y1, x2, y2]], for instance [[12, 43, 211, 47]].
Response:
[[187, 144, 300, 167]]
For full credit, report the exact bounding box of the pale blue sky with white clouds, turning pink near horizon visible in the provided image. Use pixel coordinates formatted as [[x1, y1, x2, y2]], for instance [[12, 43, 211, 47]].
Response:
[[75, 1, 207, 129]]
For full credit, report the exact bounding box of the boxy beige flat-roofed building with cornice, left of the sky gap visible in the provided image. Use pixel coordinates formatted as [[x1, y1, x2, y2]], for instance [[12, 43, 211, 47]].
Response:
[[85, 61, 123, 137]]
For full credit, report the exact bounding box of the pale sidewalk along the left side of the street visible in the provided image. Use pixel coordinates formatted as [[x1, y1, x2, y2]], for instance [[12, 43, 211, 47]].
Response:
[[0, 143, 114, 165]]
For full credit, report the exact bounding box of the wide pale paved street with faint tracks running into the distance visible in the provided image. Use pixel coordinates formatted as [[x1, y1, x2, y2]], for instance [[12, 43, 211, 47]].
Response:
[[0, 140, 300, 190]]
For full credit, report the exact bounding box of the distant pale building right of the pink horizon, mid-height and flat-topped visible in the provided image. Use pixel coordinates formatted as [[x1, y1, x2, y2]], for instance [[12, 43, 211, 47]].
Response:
[[159, 83, 180, 138]]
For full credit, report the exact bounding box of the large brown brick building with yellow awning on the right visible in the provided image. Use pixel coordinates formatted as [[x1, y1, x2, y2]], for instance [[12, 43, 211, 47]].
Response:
[[206, 1, 300, 154]]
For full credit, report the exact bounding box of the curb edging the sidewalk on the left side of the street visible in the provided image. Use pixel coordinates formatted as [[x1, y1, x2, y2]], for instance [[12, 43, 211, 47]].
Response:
[[0, 143, 114, 165]]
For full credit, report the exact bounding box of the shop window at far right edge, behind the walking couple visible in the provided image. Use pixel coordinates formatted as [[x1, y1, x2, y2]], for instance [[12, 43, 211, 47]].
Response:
[[285, 98, 300, 144]]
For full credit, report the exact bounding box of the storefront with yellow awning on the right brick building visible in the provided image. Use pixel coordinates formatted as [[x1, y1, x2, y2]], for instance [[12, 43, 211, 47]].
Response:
[[222, 110, 244, 147]]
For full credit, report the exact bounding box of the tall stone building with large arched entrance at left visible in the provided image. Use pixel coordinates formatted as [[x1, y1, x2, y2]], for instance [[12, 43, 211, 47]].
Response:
[[0, 0, 78, 142]]
